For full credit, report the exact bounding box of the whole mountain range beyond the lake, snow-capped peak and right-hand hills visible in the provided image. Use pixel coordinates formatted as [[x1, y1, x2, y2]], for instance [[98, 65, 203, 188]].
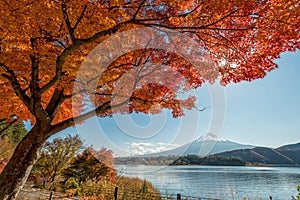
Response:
[[115, 137, 300, 166]]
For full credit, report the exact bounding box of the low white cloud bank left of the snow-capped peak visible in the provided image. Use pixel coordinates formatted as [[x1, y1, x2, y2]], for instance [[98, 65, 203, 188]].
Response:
[[125, 142, 179, 155]]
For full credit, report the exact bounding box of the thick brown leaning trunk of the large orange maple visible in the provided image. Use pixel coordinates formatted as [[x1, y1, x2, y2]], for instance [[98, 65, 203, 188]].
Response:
[[0, 125, 47, 200]]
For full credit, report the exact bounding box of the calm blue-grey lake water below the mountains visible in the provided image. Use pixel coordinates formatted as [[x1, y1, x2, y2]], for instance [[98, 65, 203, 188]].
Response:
[[117, 165, 300, 200]]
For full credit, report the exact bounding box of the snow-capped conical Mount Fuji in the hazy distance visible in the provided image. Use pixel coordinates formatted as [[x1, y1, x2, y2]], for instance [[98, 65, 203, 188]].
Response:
[[141, 133, 255, 157]]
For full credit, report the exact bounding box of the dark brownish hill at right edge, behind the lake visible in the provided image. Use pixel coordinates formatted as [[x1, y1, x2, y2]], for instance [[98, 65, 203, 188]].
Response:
[[214, 143, 300, 165]]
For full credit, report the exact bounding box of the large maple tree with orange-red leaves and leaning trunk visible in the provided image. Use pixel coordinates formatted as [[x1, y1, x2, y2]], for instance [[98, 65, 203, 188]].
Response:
[[0, 0, 300, 199]]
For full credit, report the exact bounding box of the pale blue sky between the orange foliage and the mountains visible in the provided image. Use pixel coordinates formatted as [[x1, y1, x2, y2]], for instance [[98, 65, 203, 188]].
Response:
[[59, 51, 300, 156]]
